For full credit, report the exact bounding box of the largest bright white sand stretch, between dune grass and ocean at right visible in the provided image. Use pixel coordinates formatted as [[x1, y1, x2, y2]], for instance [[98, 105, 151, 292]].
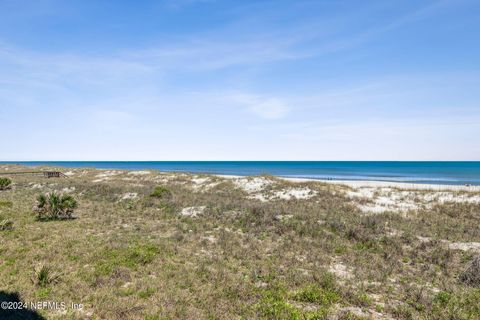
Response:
[[219, 175, 480, 209]]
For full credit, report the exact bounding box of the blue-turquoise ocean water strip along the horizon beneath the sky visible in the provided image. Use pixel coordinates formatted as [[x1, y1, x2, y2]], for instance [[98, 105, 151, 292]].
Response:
[[1, 161, 480, 185]]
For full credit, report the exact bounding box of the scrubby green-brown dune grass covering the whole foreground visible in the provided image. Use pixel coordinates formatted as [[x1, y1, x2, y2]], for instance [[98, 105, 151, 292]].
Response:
[[0, 169, 480, 320]]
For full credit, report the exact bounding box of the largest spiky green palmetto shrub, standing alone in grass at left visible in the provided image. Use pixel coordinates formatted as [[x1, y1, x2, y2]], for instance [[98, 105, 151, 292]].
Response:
[[34, 193, 77, 220]]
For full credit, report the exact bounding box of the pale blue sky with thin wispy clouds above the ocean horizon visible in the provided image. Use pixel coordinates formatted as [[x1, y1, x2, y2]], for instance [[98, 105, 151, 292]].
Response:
[[0, 0, 480, 161]]
